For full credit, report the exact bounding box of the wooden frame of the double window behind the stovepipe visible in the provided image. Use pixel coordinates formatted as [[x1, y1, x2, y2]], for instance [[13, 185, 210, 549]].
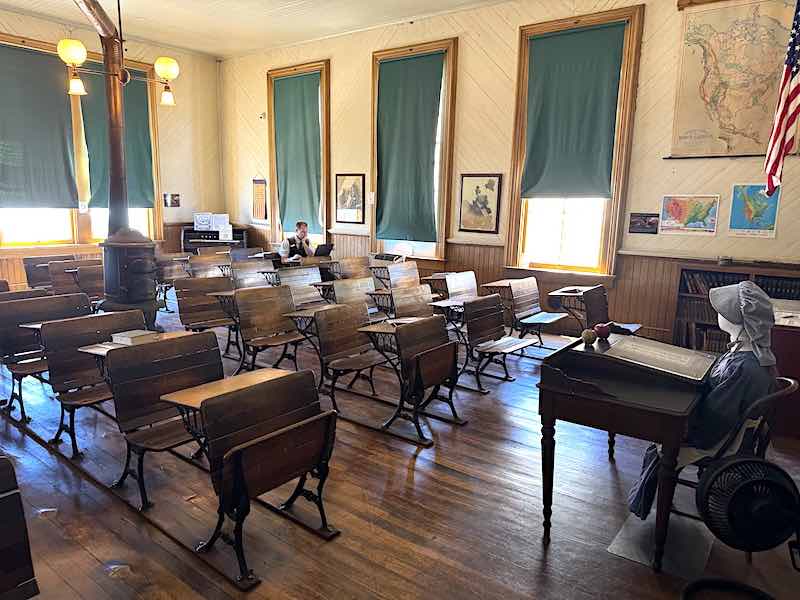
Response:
[[0, 32, 164, 250]]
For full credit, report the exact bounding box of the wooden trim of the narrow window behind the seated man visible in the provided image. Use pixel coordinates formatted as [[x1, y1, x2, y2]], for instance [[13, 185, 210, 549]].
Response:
[[266, 58, 333, 244]]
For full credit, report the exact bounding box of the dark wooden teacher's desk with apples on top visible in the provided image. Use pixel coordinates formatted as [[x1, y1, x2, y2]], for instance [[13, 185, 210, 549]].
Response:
[[539, 335, 715, 571]]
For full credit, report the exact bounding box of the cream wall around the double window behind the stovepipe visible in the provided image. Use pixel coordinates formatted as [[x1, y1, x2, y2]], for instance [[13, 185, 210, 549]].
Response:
[[0, 5, 224, 222]]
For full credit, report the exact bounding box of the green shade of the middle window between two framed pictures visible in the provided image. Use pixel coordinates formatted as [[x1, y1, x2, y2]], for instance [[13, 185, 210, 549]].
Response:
[[376, 52, 444, 242]]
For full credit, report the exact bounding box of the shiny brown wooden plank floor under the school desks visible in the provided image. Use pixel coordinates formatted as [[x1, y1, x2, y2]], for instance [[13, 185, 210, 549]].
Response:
[[0, 298, 800, 600]]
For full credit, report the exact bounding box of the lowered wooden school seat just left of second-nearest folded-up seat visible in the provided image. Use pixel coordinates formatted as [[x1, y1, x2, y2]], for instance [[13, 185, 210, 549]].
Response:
[[315, 304, 388, 411]]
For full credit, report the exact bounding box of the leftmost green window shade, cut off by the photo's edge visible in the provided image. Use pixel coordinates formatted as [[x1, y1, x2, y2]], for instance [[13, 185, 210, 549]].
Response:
[[0, 45, 78, 208]]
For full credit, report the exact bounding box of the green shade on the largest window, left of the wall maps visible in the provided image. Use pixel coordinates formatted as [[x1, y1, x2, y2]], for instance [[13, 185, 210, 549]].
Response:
[[521, 23, 625, 198]]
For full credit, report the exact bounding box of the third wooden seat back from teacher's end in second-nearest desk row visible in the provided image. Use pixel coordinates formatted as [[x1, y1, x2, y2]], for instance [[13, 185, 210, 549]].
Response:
[[236, 286, 295, 343]]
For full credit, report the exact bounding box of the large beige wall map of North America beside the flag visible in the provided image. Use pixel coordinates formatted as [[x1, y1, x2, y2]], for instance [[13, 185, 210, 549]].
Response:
[[672, 0, 794, 156]]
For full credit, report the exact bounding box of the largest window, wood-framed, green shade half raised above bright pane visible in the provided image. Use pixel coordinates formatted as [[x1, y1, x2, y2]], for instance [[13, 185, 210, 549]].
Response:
[[506, 6, 644, 274]]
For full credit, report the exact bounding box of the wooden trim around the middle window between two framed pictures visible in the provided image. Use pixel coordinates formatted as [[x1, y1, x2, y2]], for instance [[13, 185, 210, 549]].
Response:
[[367, 37, 458, 260]]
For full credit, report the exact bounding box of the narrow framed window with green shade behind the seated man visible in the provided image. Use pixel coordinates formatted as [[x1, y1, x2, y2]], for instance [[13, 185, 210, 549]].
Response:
[[267, 60, 330, 243]]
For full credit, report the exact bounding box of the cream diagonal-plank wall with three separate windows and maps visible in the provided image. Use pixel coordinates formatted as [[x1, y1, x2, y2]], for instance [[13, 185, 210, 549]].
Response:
[[222, 0, 800, 260]]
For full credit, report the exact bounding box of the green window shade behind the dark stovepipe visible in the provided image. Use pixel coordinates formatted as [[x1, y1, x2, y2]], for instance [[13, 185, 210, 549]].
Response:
[[81, 63, 155, 208]]
